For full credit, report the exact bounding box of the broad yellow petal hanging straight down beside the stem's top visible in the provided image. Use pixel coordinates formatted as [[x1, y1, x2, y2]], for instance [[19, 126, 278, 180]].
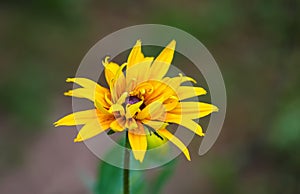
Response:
[[128, 122, 147, 162]]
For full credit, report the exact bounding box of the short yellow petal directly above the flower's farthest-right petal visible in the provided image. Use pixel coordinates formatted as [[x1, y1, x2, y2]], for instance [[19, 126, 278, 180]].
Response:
[[176, 86, 207, 100]]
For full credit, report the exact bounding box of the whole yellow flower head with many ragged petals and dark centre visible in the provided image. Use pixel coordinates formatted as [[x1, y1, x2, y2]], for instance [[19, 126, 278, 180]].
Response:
[[54, 40, 218, 162]]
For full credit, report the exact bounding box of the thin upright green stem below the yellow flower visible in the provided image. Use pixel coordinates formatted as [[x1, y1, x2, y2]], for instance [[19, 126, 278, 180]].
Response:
[[123, 131, 130, 194]]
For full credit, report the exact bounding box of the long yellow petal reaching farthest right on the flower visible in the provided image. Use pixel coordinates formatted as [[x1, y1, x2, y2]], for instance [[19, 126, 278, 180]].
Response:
[[170, 102, 218, 119]]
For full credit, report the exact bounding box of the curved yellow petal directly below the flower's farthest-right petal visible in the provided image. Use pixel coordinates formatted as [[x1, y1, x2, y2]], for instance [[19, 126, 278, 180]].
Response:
[[165, 113, 204, 136]]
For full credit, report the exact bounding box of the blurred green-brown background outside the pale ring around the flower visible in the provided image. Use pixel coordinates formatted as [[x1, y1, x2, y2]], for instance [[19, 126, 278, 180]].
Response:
[[0, 0, 300, 194]]
